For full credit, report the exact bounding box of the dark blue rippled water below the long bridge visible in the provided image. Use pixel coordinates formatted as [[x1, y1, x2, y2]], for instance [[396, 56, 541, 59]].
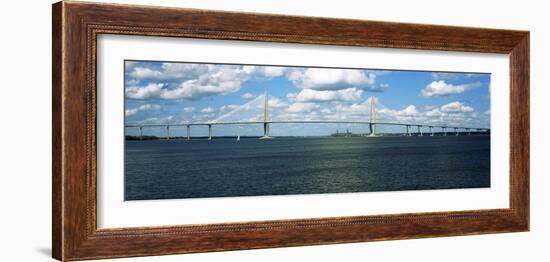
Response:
[[125, 136, 490, 200]]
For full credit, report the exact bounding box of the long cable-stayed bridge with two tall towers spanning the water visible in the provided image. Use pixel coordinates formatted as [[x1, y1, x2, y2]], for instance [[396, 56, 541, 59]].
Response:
[[124, 92, 491, 140]]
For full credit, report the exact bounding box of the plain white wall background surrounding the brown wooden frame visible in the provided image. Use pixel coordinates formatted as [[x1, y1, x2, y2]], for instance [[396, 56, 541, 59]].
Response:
[[0, 0, 550, 261]]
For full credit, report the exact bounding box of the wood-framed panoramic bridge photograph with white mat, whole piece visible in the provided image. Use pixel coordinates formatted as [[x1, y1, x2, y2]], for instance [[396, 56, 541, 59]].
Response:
[[52, 2, 529, 261]]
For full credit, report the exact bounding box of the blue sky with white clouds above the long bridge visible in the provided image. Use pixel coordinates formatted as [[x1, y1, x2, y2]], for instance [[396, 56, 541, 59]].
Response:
[[124, 61, 491, 136]]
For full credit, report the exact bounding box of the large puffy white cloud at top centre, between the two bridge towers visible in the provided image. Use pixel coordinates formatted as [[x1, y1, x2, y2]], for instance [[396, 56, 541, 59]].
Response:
[[287, 68, 376, 90]]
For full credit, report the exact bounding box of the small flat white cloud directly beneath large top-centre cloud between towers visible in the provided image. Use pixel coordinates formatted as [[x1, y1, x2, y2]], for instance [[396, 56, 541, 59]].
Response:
[[294, 87, 363, 102]]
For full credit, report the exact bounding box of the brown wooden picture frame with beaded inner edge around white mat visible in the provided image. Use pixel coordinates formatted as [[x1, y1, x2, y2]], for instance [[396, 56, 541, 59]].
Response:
[[52, 2, 529, 261]]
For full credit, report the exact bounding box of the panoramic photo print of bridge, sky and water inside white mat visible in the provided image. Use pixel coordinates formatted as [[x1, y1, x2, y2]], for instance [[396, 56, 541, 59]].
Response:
[[124, 60, 491, 201]]
